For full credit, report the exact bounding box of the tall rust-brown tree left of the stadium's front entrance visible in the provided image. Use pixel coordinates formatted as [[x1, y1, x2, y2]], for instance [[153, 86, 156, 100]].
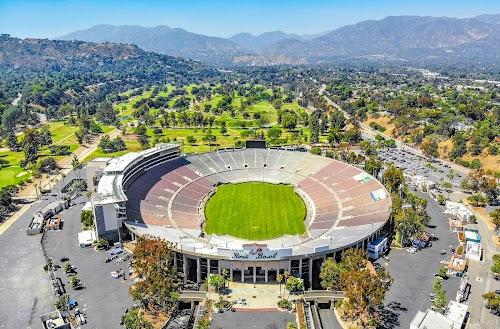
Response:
[[129, 237, 180, 311]]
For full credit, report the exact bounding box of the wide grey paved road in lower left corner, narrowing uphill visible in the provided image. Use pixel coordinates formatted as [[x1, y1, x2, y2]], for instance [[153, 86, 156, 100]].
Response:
[[0, 169, 82, 328]]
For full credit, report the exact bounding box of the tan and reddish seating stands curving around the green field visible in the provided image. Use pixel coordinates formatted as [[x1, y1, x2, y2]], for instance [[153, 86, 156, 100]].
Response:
[[127, 149, 390, 236]]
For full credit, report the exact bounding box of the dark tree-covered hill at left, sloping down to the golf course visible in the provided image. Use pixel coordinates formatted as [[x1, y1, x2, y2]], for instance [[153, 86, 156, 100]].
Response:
[[0, 35, 218, 111]]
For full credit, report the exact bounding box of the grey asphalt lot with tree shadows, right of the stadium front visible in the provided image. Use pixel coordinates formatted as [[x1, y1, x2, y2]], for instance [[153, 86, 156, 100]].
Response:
[[376, 193, 460, 328]]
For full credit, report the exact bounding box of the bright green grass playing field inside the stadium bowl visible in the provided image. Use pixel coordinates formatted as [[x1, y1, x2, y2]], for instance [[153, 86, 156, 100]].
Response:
[[205, 182, 306, 240]]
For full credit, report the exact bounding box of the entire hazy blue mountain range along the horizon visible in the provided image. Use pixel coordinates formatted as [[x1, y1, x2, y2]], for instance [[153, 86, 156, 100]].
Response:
[[60, 14, 500, 65]]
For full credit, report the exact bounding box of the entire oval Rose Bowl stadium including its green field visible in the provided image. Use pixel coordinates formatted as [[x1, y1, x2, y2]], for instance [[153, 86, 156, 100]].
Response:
[[92, 143, 391, 288]]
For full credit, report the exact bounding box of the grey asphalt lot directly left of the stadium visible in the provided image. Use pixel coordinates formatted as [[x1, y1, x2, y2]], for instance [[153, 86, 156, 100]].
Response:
[[47, 197, 132, 329]]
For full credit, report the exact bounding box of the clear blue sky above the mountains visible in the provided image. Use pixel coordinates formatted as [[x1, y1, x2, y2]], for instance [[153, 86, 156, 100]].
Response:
[[0, 0, 500, 38]]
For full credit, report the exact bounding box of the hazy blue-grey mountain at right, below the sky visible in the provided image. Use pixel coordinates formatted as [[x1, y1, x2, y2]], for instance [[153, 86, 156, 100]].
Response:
[[268, 15, 500, 64]]
